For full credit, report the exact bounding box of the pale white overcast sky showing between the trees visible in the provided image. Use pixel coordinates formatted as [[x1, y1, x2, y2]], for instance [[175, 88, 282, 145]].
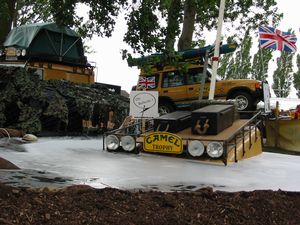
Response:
[[88, 0, 300, 97]]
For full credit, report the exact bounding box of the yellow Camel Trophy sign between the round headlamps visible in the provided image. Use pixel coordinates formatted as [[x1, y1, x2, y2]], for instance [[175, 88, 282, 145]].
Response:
[[143, 132, 183, 154]]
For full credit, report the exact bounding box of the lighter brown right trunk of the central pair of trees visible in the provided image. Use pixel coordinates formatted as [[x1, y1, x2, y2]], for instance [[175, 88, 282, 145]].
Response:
[[178, 0, 196, 51]]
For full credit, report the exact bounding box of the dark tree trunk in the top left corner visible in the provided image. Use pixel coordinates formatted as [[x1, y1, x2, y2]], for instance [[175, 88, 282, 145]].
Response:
[[0, 0, 17, 47]]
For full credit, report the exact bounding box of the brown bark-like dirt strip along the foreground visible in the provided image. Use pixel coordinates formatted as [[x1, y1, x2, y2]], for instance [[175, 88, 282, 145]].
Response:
[[0, 158, 300, 225]]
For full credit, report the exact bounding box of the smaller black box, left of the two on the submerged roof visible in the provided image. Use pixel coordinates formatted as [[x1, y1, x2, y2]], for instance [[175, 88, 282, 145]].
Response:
[[154, 111, 191, 133]]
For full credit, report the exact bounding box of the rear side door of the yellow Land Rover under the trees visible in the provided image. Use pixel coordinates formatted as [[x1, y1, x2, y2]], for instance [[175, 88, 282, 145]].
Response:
[[160, 70, 188, 102]]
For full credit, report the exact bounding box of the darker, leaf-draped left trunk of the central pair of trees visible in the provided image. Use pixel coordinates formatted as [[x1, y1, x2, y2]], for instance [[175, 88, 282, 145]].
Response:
[[165, 0, 181, 52]]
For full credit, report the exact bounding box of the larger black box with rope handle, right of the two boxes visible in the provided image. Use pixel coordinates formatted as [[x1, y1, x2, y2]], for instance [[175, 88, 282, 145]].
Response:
[[191, 105, 234, 135]]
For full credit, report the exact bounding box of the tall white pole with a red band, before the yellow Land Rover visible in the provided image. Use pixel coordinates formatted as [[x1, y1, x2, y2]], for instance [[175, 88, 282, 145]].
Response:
[[208, 0, 225, 100]]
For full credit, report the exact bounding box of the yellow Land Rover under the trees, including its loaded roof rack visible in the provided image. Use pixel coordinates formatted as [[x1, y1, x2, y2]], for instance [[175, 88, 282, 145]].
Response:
[[128, 45, 263, 113]]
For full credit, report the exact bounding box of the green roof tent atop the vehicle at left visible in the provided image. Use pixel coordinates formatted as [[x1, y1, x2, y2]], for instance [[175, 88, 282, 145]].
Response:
[[4, 23, 87, 65]]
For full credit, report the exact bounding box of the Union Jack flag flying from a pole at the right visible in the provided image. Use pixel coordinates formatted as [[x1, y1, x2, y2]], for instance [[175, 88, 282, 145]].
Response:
[[259, 27, 297, 52]]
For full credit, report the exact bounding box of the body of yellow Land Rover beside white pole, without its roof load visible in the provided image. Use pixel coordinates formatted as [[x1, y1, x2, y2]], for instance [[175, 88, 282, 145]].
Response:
[[136, 64, 263, 113]]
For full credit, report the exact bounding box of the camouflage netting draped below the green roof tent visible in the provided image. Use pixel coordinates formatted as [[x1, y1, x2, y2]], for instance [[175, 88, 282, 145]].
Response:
[[0, 66, 129, 134]]
